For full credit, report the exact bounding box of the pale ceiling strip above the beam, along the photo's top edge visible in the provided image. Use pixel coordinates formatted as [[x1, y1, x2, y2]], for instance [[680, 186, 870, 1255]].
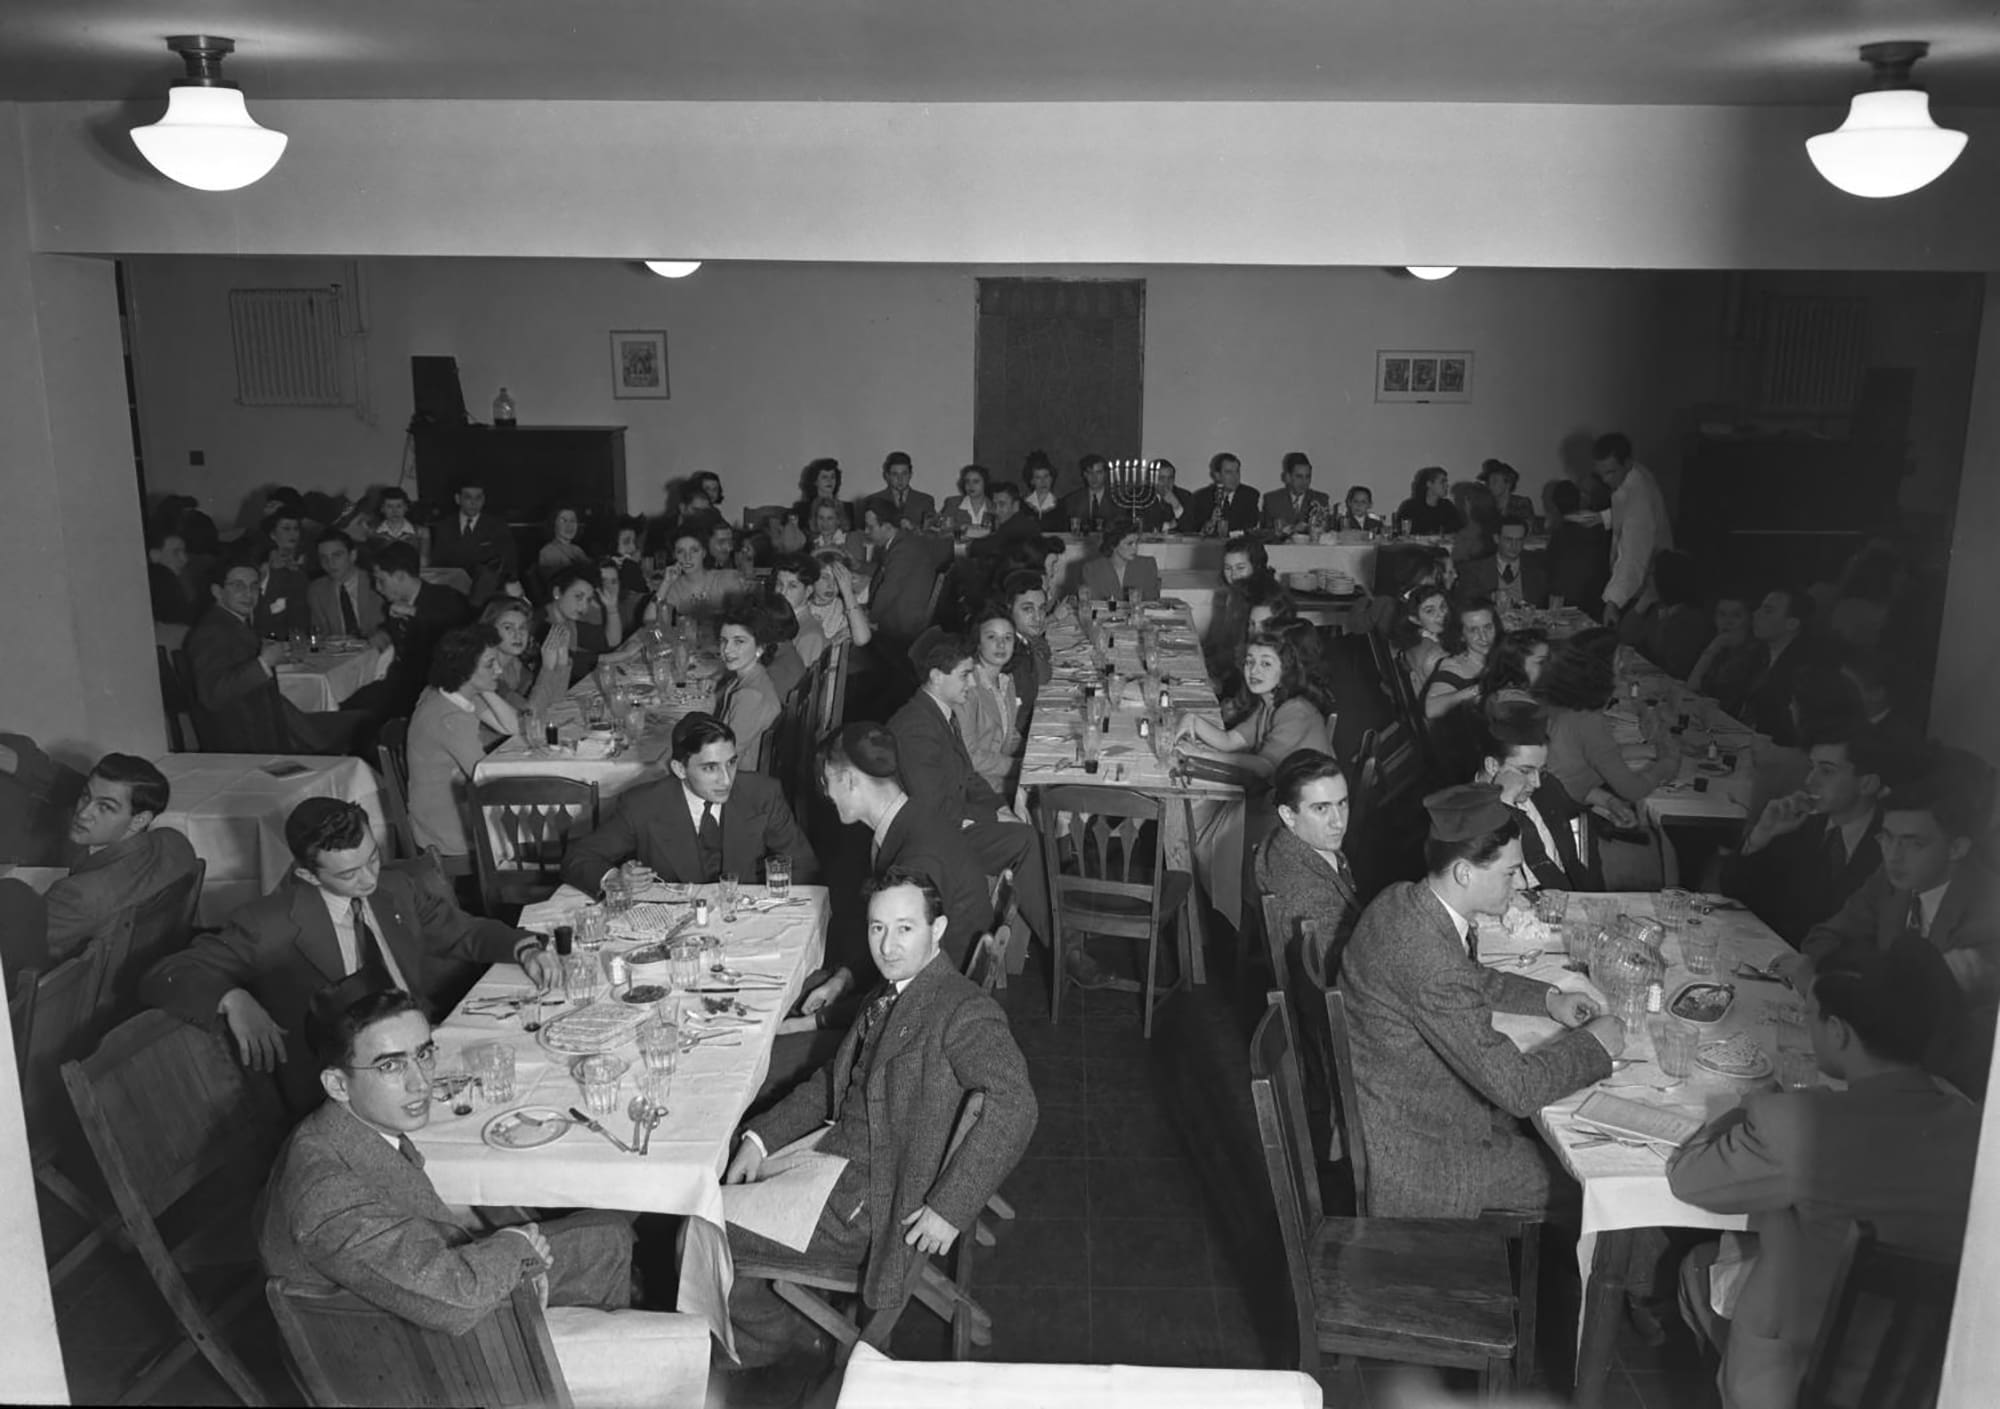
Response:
[[0, 0, 2000, 107]]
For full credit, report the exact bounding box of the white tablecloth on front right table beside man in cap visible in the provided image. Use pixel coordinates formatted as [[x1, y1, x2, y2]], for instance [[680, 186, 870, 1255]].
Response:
[[1478, 893, 1800, 1352]]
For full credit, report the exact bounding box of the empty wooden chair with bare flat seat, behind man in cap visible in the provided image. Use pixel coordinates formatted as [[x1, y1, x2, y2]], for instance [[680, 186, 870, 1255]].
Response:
[[1250, 993, 1516, 1397]]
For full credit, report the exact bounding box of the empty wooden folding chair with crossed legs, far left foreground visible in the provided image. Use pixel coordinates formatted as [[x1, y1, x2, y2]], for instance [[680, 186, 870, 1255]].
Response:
[[62, 1011, 284, 1405]]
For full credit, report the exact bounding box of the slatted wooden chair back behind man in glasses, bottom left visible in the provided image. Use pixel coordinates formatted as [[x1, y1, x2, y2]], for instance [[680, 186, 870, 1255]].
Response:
[[264, 1277, 572, 1409]]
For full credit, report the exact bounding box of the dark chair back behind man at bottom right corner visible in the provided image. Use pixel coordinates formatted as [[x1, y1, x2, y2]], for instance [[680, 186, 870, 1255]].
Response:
[[1798, 1223, 1958, 1409]]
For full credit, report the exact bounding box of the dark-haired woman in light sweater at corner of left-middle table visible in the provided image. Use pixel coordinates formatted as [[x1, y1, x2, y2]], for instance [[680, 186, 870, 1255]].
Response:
[[408, 626, 520, 857]]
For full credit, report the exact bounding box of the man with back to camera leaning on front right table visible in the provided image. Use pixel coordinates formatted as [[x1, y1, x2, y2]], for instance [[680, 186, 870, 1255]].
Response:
[[1666, 953, 1980, 1409]]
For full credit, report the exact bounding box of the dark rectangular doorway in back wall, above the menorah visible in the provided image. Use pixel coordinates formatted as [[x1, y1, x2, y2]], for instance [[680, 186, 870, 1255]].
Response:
[[972, 278, 1146, 494]]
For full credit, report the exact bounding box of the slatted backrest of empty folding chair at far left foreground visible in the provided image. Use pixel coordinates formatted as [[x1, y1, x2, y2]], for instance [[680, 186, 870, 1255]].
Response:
[[62, 1011, 284, 1223]]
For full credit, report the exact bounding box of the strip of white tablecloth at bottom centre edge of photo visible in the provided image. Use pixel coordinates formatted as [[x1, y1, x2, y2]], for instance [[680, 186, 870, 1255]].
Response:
[[838, 1345, 1322, 1409]]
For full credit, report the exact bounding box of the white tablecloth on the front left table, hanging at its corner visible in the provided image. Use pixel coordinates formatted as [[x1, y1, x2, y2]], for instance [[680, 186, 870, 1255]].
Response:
[[416, 885, 828, 1345]]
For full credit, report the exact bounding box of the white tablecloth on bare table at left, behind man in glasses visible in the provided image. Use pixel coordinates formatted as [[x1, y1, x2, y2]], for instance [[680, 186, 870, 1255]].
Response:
[[154, 753, 388, 925]]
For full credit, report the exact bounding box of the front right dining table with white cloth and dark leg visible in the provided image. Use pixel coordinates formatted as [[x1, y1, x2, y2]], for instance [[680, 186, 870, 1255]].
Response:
[[1478, 895, 1804, 1405]]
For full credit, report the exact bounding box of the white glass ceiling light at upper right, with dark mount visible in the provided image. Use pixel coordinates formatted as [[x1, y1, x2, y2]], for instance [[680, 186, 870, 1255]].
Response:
[[1806, 40, 1966, 198]]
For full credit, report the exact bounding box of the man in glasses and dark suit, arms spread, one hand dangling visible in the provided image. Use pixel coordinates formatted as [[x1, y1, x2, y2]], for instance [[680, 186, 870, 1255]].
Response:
[[140, 797, 548, 1109]]
